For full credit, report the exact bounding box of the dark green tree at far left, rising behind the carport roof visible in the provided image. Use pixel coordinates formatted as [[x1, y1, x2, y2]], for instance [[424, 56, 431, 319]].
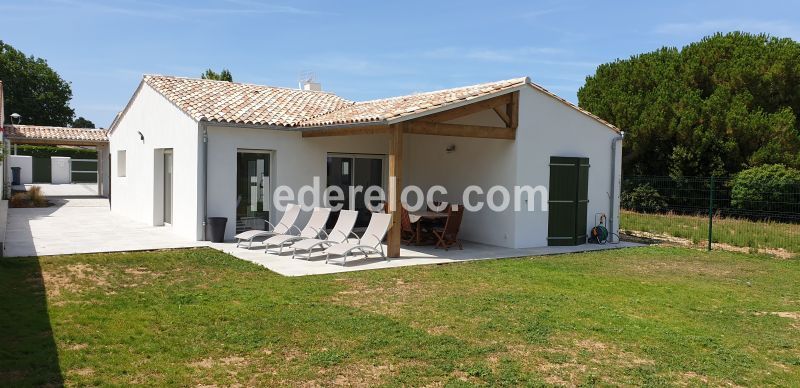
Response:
[[0, 41, 75, 126]]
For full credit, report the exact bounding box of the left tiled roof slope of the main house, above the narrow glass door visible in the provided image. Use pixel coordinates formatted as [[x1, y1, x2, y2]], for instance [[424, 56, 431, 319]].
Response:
[[144, 75, 353, 126]]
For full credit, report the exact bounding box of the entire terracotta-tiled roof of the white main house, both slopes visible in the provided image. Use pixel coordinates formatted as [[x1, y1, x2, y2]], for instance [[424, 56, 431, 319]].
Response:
[[138, 75, 620, 132]]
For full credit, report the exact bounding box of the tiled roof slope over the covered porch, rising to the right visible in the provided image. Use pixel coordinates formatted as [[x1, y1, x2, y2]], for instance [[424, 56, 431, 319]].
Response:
[[299, 77, 530, 127]]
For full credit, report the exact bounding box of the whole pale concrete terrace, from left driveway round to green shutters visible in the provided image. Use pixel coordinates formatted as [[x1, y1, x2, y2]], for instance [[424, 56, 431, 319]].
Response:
[[5, 184, 639, 276]]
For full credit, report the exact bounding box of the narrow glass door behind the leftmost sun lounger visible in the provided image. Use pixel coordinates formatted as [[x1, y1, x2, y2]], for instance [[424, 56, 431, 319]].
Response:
[[236, 151, 271, 233]]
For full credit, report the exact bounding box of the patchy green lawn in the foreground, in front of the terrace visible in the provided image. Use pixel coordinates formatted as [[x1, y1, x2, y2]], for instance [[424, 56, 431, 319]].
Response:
[[0, 247, 800, 386]]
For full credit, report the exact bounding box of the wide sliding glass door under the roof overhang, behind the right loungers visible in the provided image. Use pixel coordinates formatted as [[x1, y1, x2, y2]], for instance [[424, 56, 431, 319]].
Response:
[[327, 154, 386, 227]]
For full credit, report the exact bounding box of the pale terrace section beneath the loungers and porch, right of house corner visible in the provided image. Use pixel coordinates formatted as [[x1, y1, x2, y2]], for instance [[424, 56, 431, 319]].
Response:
[[210, 242, 641, 276]]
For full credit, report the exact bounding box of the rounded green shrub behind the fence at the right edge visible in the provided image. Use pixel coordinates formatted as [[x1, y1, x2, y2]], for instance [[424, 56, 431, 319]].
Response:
[[730, 164, 800, 212]]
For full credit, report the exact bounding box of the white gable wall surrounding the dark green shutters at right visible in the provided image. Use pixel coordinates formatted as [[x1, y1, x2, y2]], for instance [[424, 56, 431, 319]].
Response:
[[515, 88, 622, 248]]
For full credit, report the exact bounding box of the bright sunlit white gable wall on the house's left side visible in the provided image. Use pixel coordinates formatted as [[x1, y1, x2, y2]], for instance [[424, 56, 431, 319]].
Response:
[[108, 84, 203, 240]]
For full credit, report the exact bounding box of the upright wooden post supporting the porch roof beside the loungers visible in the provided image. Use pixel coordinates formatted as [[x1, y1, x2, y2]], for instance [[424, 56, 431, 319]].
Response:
[[386, 124, 406, 257]]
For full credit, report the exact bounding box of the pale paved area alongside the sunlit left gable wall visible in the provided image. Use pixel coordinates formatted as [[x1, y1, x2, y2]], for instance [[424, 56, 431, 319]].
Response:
[[5, 197, 206, 257]]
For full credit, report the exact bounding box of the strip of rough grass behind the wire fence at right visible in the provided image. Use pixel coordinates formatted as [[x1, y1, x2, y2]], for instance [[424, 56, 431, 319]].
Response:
[[620, 210, 800, 254]]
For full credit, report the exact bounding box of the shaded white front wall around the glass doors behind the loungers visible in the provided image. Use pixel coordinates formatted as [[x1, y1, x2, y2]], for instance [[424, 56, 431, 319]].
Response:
[[205, 125, 389, 239]]
